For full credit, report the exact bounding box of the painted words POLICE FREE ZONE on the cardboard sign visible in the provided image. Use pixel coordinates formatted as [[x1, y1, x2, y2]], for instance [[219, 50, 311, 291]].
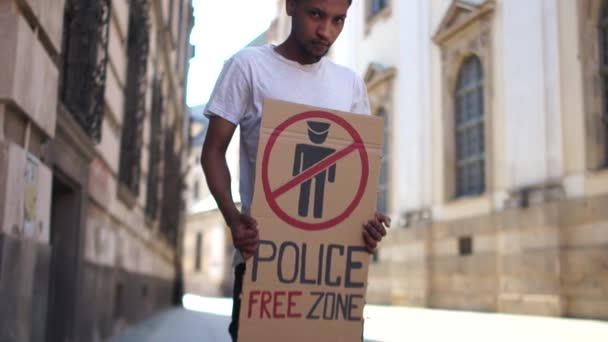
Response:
[[247, 240, 369, 321]]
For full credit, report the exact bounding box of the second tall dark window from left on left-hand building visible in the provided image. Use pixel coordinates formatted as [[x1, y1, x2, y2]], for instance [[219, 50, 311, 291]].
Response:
[[119, 0, 149, 195]]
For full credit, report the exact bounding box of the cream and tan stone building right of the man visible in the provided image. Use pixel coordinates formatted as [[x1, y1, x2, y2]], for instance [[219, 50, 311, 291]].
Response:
[[349, 0, 608, 319]]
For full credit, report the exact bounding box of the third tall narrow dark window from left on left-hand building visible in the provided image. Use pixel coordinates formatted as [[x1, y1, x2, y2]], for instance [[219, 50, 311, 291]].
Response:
[[146, 77, 164, 219]]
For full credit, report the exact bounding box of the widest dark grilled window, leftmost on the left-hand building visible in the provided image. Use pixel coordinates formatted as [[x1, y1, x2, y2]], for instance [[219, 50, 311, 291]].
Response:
[[59, 0, 111, 142]]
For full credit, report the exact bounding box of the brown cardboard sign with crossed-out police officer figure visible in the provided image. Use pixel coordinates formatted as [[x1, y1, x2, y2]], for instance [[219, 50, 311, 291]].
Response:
[[239, 99, 384, 342]]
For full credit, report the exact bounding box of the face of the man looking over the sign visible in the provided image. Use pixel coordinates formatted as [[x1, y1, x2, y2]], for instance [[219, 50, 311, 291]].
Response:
[[287, 0, 349, 60]]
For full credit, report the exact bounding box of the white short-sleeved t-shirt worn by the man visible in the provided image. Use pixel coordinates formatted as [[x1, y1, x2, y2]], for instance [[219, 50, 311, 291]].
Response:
[[205, 44, 370, 209]]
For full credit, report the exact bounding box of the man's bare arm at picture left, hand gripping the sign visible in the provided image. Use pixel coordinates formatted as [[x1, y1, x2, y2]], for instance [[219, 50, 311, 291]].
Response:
[[201, 116, 259, 259]]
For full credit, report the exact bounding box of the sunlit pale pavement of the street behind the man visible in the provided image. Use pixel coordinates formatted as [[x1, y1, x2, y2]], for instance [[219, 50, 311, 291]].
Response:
[[112, 295, 608, 342]]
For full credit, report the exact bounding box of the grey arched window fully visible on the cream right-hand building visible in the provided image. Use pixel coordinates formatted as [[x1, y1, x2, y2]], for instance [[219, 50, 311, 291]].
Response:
[[454, 56, 485, 197]]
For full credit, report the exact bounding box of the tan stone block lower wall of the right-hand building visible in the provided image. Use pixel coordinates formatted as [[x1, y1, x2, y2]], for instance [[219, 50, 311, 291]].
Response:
[[368, 190, 608, 319]]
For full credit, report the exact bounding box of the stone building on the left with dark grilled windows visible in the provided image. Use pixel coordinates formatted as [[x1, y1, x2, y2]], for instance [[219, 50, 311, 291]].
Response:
[[0, 0, 193, 341]]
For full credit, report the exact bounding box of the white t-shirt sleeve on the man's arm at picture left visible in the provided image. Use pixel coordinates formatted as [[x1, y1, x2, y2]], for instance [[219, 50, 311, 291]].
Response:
[[204, 57, 252, 125]]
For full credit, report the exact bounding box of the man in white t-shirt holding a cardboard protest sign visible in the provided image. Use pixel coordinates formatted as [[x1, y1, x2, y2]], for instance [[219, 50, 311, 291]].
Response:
[[201, 0, 390, 341]]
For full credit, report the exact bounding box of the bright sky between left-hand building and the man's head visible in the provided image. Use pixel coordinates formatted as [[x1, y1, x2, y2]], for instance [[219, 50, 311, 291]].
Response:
[[186, 0, 277, 106]]
